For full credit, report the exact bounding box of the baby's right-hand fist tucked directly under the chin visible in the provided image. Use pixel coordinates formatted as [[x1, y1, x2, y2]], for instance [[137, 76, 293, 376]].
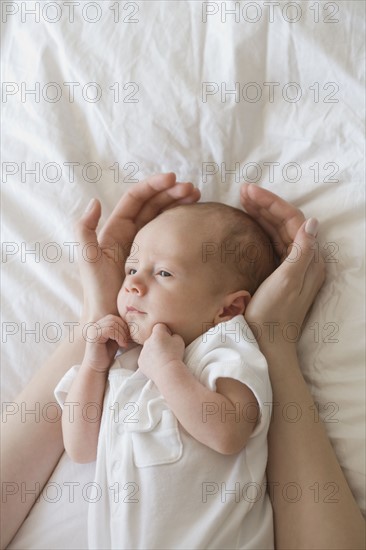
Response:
[[138, 323, 185, 381]]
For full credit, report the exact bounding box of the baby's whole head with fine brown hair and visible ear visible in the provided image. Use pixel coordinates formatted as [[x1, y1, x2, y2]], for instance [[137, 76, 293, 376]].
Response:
[[117, 202, 275, 345]]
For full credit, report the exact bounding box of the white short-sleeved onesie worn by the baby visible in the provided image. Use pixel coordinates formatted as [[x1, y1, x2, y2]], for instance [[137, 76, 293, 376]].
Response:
[[55, 315, 274, 550]]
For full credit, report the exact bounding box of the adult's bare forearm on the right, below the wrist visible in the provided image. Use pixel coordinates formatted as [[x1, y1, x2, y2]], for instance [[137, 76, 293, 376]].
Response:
[[263, 344, 364, 550]]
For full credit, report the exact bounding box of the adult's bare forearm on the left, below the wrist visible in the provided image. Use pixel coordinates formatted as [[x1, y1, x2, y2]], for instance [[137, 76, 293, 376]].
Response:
[[1, 330, 85, 548]]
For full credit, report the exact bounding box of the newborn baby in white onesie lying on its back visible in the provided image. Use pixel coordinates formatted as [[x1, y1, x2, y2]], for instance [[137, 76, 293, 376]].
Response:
[[55, 203, 275, 550]]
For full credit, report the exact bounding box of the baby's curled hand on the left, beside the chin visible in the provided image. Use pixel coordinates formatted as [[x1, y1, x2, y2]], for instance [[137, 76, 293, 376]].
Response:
[[83, 314, 130, 372]]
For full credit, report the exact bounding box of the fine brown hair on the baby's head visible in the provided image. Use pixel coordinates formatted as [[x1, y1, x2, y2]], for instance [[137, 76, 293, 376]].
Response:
[[170, 202, 276, 296]]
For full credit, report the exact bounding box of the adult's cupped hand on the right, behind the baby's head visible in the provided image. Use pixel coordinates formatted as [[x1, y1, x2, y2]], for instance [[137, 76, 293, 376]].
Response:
[[240, 184, 325, 349]]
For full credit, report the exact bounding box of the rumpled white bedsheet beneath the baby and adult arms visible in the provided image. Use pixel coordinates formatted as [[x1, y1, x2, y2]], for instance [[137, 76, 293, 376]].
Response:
[[1, 0, 365, 549]]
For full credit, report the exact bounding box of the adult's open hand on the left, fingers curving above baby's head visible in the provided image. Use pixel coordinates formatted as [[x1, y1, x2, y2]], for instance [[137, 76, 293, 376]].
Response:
[[75, 173, 200, 321]]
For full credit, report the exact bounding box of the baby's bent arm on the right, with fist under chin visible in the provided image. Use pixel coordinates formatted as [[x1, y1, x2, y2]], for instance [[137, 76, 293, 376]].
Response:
[[139, 324, 259, 454]]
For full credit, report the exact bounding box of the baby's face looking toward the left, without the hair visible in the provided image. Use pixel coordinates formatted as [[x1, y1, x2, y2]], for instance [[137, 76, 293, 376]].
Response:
[[117, 212, 223, 345]]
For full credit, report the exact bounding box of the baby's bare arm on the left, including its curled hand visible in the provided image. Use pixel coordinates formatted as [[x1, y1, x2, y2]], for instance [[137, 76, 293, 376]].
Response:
[[62, 315, 128, 463]]
